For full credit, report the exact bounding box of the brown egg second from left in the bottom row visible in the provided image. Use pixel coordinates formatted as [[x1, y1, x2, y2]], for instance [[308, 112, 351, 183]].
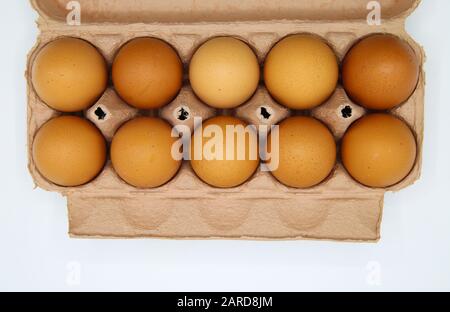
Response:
[[111, 117, 181, 188]]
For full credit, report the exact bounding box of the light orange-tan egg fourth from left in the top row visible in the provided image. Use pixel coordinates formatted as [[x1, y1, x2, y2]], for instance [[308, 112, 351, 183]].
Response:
[[264, 34, 339, 110]]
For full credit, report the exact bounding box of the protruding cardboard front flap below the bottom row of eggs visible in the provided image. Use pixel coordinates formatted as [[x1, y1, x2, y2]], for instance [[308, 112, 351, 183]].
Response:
[[68, 194, 384, 242]]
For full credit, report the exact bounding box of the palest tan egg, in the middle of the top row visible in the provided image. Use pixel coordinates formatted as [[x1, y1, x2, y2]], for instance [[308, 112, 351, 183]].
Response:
[[189, 37, 260, 108]]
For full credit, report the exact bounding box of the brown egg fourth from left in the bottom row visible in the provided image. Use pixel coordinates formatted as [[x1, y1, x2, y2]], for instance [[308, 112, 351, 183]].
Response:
[[268, 116, 336, 188]]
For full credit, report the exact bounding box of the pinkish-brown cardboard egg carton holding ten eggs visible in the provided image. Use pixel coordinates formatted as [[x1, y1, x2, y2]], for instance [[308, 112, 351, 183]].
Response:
[[27, 0, 424, 242]]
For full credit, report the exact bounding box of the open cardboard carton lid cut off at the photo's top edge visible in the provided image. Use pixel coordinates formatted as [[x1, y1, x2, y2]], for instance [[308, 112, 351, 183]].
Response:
[[32, 0, 420, 24]]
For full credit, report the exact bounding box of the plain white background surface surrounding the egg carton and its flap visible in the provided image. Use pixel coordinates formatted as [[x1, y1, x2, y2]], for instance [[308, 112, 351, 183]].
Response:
[[0, 0, 450, 291]]
